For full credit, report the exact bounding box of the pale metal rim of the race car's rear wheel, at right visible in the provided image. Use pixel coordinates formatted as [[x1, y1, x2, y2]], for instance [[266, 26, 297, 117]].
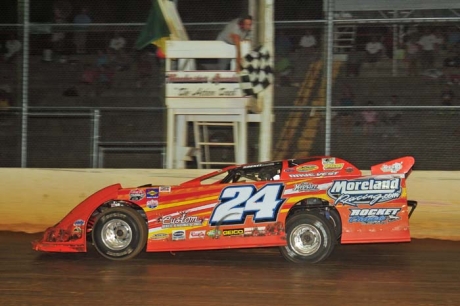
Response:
[[289, 224, 322, 256]]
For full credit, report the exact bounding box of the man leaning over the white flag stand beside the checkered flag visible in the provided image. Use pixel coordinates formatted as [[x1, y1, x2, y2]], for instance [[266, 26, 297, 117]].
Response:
[[217, 15, 252, 72]]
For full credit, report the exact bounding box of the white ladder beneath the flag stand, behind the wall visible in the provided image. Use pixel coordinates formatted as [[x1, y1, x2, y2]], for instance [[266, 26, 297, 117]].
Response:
[[193, 121, 238, 169]]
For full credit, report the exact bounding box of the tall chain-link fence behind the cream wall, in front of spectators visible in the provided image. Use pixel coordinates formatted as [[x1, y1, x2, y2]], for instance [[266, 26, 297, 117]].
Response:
[[0, 0, 460, 170]]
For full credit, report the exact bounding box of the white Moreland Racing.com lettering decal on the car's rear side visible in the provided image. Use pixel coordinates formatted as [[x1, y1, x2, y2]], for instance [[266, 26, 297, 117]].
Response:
[[327, 178, 402, 206]]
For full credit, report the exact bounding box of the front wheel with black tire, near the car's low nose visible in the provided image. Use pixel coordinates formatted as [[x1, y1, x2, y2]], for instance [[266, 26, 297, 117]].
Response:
[[92, 207, 148, 260]]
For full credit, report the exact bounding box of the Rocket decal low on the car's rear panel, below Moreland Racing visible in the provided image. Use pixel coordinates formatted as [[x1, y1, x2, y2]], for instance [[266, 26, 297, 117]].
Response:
[[348, 208, 401, 224]]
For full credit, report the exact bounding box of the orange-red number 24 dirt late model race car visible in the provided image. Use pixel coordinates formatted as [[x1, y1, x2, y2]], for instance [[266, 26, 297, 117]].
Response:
[[32, 156, 417, 263]]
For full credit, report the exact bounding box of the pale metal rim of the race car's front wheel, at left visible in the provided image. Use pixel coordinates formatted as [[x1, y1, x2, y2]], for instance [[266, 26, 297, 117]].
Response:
[[101, 219, 133, 251]]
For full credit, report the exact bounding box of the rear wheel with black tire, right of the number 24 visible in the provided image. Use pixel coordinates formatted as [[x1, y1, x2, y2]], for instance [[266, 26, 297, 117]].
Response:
[[280, 212, 336, 263]]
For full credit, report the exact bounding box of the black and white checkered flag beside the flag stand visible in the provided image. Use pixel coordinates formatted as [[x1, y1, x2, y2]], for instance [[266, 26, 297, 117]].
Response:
[[240, 46, 273, 97]]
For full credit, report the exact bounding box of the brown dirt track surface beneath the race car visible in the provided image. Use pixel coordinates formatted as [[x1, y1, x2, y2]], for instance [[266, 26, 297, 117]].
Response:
[[0, 232, 460, 306]]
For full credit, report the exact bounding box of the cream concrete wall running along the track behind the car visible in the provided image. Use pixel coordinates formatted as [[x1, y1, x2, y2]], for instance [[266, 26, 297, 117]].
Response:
[[0, 168, 460, 241]]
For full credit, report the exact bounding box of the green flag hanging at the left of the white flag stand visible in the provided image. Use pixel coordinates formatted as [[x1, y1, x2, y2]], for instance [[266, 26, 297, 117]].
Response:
[[136, 0, 171, 52]]
